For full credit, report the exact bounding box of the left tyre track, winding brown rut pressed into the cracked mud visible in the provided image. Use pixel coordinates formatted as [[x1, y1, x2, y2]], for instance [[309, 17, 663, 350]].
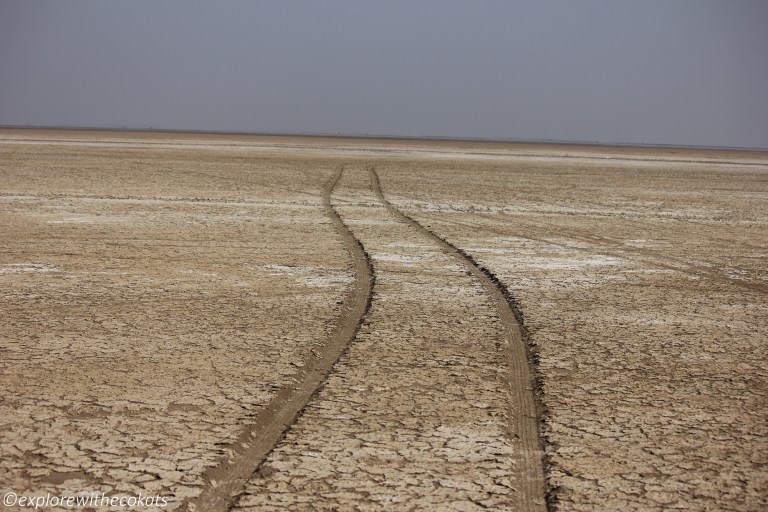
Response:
[[187, 168, 374, 512]]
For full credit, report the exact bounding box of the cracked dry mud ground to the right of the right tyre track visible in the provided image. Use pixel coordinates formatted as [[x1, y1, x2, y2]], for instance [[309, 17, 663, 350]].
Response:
[[379, 160, 768, 511]]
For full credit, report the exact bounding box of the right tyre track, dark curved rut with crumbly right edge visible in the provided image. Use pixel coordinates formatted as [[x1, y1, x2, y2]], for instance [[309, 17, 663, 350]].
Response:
[[369, 167, 555, 512]]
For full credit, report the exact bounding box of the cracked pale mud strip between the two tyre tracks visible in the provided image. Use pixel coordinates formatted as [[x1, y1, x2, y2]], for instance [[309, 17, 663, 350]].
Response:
[[236, 166, 545, 510]]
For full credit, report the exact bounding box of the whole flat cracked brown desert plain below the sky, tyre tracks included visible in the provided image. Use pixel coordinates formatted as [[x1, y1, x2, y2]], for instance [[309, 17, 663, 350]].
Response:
[[0, 130, 768, 511]]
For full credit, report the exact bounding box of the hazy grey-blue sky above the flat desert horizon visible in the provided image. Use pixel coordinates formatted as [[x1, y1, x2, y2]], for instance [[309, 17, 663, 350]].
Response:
[[0, 0, 768, 147]]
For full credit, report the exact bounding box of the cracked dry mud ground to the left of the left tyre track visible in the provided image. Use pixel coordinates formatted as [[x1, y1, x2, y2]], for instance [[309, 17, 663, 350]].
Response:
[[0, 139, 355, 510]]
